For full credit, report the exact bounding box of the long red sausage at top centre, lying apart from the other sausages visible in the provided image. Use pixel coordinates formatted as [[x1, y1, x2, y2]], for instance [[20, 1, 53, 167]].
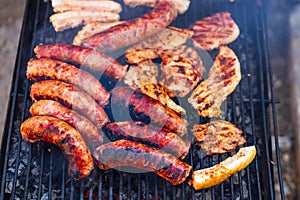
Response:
[[83, 0, 177, 51]]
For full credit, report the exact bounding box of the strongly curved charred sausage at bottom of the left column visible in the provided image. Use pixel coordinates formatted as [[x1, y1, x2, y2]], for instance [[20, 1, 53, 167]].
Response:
[[20, 116, 94, 179]]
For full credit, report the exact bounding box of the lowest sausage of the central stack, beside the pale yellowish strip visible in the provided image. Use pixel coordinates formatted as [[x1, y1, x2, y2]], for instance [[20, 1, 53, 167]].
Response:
[[94, 140, 192, 185]]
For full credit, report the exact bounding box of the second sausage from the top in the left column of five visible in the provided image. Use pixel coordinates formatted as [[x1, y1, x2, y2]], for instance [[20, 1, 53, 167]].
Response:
[[26, 58, 109, 106]]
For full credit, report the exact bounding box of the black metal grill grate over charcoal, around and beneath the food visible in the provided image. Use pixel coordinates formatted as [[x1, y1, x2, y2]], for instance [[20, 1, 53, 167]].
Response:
[[0, 0, 284, 199]]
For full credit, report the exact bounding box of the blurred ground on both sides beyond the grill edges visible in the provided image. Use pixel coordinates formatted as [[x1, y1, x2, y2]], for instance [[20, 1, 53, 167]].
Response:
[[0, 0, 300, 199]]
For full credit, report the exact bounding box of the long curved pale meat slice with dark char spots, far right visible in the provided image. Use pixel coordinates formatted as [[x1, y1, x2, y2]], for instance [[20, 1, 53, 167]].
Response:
[[188, 46, 241, 117]]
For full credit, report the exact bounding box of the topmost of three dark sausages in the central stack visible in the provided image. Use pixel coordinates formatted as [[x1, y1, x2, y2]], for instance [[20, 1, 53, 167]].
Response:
[[111, 87, 188, 136]]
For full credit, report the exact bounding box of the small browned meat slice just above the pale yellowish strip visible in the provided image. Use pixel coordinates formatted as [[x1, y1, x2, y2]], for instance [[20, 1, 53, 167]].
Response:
[[192, 120, 246, 155]]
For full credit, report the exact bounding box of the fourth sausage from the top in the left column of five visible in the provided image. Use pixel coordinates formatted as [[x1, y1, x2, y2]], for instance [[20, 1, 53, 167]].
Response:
[[29, 100, 104, 149]]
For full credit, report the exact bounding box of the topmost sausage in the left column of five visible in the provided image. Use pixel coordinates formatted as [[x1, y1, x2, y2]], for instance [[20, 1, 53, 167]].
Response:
[[34, 44, 128, 82]]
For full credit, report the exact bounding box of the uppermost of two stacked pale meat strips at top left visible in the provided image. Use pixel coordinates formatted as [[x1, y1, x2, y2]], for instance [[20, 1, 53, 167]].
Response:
[[51, 0, 122, 13]]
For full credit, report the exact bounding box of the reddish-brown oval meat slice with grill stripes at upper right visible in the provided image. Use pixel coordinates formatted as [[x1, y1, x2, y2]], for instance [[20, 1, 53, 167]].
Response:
[[190, 12, 240, 50]]
